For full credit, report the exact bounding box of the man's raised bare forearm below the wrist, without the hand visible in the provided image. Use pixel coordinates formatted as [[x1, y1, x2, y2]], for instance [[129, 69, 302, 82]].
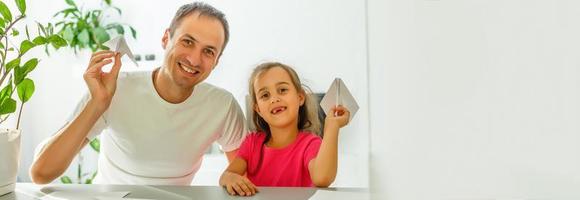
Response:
[[30, 102, 103, 184]]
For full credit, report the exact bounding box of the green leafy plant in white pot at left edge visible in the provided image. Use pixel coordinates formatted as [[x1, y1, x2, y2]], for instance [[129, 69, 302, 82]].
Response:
[[0, 0, 67, 195]]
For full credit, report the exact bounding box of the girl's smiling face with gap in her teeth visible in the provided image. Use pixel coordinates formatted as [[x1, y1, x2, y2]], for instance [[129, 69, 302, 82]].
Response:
[[254, 67, 304, 128]]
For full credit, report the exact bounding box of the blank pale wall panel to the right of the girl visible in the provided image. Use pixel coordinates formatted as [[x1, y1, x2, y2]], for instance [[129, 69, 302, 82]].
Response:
[[368, 0, 580, 199]]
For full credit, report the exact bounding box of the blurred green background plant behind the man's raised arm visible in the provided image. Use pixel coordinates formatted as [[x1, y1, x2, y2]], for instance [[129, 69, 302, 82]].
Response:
[[54, 0, 137, 184]]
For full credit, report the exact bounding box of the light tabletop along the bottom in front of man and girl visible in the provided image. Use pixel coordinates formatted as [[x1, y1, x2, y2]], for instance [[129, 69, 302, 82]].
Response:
[[0, 183, 369, 200]]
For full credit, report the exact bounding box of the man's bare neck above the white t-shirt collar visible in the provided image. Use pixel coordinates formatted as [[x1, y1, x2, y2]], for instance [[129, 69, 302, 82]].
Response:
[[152, 67, 193, 104]]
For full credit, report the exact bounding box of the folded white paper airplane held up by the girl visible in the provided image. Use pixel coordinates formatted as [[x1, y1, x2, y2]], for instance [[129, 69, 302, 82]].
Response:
[[320, 78, 359, 121]]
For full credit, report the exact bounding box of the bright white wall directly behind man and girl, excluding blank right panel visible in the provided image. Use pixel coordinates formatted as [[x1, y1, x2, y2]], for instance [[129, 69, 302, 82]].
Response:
[[15, 0, 369, 187]]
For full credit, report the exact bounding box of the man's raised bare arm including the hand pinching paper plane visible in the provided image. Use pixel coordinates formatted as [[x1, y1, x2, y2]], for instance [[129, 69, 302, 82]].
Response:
[[30, 51, 121, 184]]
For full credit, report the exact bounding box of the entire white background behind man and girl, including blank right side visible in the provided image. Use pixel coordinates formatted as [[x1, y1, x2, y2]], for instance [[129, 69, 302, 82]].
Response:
[[4, 0, 580, 199]]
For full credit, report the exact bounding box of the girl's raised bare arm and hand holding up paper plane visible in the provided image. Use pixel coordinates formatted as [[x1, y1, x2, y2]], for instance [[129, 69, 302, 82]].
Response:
[[308, 106, 350, 187]]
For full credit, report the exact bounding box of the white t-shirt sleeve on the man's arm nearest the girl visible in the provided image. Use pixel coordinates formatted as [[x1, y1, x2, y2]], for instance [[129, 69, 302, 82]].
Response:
[[217, 97, 248, 152]]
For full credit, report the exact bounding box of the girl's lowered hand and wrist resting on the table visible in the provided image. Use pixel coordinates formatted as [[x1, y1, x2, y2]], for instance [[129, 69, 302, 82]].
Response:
[[219, 157, 258, 196]]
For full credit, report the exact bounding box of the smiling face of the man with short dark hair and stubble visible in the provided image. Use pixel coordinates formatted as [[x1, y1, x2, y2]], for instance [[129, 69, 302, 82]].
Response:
[[161, 13, 225, 89]]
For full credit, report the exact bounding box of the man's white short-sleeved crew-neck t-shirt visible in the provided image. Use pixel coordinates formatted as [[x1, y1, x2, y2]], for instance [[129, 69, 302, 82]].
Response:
[[66, 71, 247, 185]]
